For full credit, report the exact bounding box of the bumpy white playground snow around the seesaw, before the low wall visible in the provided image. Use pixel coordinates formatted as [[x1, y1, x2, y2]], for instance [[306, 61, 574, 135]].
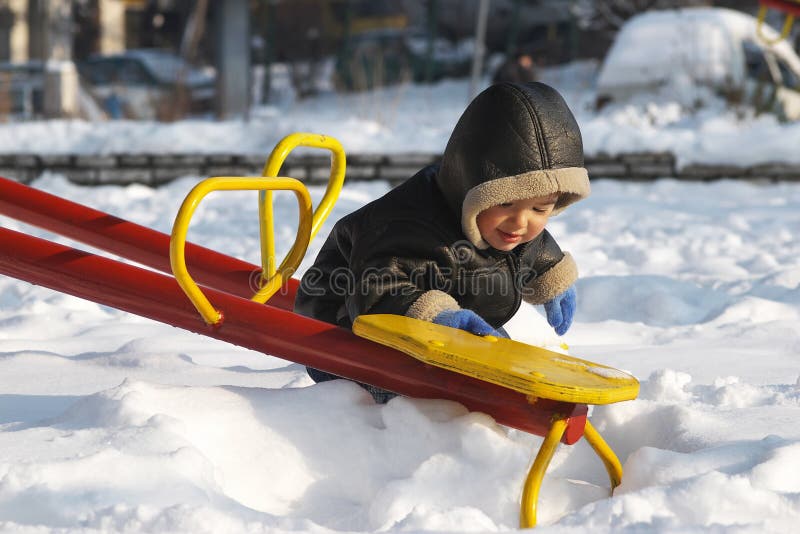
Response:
[[0, 174, 800, 533]]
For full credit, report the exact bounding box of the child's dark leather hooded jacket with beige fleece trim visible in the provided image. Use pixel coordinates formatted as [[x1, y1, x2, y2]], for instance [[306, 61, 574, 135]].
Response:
[[295, 83, 589, 328]]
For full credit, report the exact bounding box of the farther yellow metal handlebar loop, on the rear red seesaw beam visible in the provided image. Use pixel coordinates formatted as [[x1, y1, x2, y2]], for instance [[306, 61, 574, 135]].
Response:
[[258, 132, 346, 280]]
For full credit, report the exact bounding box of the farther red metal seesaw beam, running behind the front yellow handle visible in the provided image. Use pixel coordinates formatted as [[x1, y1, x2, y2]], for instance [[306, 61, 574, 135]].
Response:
[[0, 178, 298, 310]]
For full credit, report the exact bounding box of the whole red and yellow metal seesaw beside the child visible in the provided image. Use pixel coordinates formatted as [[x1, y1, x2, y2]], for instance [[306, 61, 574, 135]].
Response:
[[0, 133, 639, 527]]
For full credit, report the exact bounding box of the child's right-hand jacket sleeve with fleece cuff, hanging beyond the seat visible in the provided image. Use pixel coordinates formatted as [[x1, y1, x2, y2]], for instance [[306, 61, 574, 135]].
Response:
[[521, 230, 578, 304]]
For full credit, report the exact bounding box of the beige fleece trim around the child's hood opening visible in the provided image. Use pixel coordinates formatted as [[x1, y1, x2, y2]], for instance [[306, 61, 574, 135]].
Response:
[[461, 167, 591, 249]]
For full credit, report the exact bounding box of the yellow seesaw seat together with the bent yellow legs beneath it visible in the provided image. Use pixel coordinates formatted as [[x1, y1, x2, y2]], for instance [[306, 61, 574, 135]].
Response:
[[353, 315, 639, 528]]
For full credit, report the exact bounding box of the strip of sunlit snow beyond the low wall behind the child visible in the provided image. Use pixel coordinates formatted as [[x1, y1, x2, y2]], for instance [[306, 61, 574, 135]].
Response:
[[0, 62, 800, 170]]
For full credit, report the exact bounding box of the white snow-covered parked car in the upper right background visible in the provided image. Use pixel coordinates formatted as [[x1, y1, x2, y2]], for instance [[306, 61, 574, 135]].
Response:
[[597, 8, 800, 120]]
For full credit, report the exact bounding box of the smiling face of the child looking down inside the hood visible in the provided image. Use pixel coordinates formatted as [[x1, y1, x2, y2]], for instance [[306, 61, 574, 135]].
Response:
[[476, 194, 558, 251]]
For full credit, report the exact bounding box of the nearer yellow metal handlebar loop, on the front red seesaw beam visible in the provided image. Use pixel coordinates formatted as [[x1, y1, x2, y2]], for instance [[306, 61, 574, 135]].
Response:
[[169, 176, 312, 325]]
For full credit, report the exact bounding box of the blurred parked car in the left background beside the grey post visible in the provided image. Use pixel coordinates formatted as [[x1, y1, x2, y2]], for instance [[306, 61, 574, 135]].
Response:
[[78, 49, 215, 119]]
